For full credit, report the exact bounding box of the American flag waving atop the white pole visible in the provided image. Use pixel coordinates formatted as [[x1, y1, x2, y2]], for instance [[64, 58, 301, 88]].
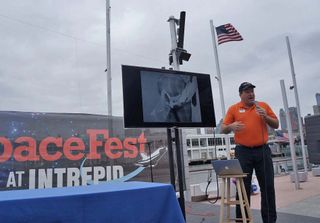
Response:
[[216, 23, 243, 44]]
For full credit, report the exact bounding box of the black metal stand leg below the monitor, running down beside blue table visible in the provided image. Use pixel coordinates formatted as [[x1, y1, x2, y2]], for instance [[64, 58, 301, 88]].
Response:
[[174, 128, 186, 219]]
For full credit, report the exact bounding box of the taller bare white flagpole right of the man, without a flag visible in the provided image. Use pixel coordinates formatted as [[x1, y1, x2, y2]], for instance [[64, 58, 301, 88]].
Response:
[[286, 36, 308, 173]]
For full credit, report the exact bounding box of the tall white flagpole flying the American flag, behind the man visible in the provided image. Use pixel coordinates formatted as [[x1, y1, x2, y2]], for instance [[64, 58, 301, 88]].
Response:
[[210, 20, 230, 159]]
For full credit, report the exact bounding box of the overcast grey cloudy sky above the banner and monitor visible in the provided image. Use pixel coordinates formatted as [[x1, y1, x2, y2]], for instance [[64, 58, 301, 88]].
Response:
[[0, 0, 320, 123]]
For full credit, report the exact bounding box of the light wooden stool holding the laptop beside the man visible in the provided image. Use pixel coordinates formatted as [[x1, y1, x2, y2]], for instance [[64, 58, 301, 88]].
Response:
[[219, 174, 252, 223]]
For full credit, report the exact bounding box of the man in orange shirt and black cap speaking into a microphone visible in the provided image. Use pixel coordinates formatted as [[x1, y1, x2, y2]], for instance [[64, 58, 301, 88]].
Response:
[[221, 82, 279, 223]]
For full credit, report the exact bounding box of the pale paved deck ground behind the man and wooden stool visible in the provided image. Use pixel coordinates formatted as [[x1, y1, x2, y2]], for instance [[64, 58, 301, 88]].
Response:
[[186, 172, 320, 223]]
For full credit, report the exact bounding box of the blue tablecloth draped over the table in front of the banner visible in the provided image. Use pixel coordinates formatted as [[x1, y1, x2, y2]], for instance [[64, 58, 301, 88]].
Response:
[[0, 182, 185, 223]]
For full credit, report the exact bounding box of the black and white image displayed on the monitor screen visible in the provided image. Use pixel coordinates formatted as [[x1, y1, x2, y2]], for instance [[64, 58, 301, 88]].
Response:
[[141, 71, 201, 123]]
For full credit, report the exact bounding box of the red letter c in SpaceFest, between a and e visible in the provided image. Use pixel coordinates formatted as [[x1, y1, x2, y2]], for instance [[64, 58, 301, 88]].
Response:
[[39, 137, 62, 161]]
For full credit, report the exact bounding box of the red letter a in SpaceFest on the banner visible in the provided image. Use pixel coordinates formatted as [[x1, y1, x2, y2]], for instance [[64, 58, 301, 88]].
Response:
[[13, 137, 39, 162]]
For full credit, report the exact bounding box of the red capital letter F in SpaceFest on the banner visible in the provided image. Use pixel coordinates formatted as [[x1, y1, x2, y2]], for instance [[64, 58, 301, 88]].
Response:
[[87, 129, 109, 159]]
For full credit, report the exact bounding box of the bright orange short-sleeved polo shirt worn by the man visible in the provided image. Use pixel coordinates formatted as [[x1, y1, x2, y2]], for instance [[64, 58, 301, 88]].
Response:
[[223, 101, 277, 147]]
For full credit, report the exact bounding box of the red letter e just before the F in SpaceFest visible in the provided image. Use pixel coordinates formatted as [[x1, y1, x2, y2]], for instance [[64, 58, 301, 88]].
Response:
[[63, 137, 85, 160]]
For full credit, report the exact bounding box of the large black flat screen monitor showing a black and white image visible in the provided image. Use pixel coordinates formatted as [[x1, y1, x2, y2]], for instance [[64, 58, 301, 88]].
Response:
[[122, 65, 216, 128]]
